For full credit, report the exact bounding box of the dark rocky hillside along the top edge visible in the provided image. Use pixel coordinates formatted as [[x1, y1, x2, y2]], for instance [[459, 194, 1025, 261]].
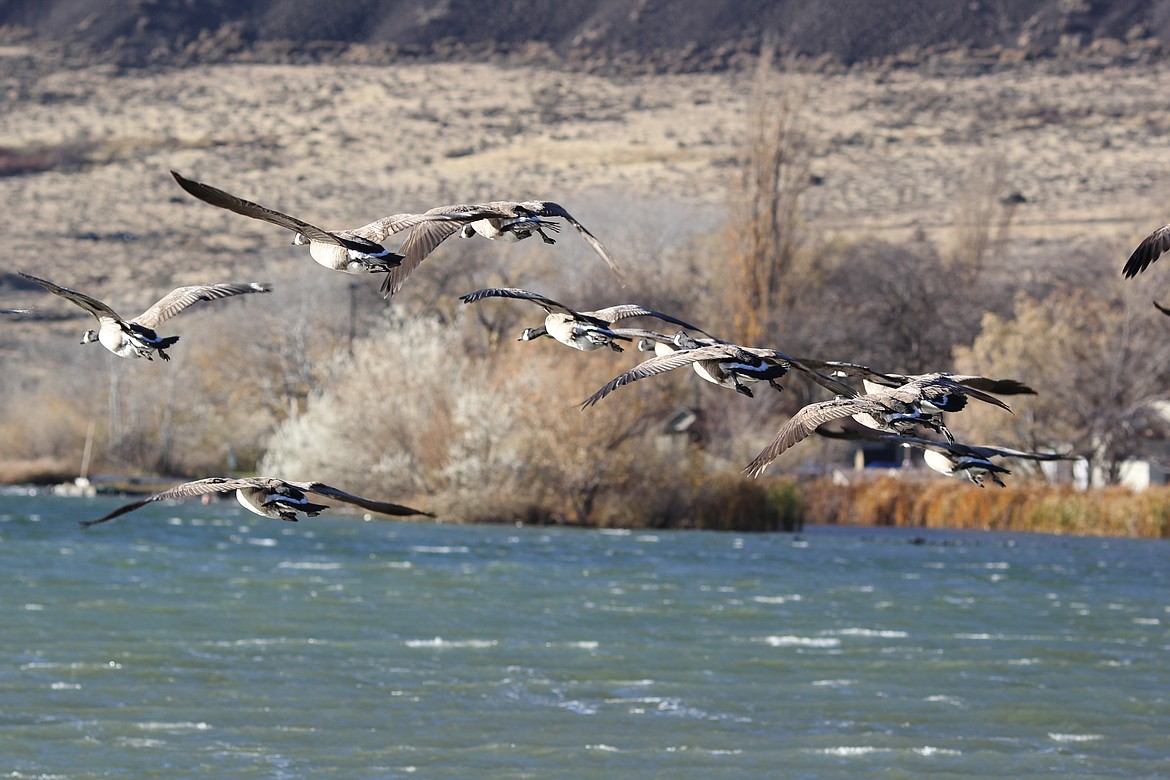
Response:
[[0, 0, 1170, 70]]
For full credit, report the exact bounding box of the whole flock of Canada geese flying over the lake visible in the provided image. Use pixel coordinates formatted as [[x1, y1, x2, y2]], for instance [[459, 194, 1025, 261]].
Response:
[[0, 171, 1170, 527]]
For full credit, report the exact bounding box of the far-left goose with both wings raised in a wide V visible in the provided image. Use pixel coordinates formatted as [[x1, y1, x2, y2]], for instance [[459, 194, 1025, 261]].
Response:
[[21, 272, 273, 360]]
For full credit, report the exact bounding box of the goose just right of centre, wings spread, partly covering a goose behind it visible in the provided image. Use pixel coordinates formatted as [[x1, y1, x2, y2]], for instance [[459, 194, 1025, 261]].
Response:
[[581, 332, 853, 408]]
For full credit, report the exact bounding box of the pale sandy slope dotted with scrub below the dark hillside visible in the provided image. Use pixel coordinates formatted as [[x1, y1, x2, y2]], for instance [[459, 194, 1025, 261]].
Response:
[[0, 48, 1170, 305]]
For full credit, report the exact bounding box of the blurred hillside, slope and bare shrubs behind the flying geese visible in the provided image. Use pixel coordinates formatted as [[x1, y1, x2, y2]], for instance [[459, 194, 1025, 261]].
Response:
[[0, 0, 1170, 527]]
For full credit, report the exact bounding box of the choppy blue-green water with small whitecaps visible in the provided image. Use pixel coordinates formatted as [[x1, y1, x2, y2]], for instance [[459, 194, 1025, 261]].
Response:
[[0, 493, 1170, 779]]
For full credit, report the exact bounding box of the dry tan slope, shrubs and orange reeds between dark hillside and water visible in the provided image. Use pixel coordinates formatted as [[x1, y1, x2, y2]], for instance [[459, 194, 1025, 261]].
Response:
[[0, 47, 1170, 533]]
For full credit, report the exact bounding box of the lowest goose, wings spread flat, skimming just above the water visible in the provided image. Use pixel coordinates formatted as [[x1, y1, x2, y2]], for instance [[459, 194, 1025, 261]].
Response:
[[81, 477, 434, 529]]
